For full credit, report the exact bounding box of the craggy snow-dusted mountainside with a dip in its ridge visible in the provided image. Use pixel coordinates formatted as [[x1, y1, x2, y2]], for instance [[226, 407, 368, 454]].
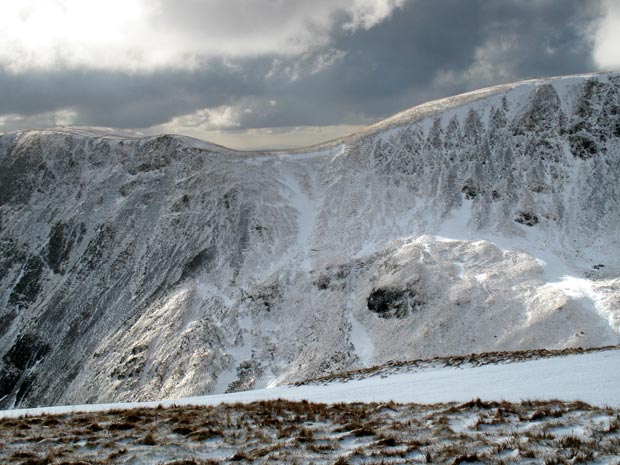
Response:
[[0, 70, 620, 408]]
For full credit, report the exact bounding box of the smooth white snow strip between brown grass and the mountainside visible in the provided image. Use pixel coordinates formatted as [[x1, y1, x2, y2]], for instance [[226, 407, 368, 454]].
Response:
[[0, 350, 620, 418]]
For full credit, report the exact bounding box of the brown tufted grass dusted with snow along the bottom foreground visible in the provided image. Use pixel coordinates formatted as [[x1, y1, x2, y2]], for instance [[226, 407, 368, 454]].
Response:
[[0, 400, 620, 465]]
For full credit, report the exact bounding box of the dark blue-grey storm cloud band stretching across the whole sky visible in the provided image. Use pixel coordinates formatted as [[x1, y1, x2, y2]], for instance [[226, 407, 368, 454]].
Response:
[[0, 0, 599, 134]]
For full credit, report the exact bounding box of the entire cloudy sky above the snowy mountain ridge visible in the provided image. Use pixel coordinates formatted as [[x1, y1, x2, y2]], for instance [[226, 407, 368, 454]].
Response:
[[0, 0, 620, 149]]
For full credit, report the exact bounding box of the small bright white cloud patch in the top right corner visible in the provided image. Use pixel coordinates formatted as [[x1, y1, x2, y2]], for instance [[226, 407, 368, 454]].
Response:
[[593, 0, 620, 70]]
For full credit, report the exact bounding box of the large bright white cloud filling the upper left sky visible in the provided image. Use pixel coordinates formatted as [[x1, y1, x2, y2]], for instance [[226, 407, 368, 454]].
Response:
[[0, 0, 406, 72]]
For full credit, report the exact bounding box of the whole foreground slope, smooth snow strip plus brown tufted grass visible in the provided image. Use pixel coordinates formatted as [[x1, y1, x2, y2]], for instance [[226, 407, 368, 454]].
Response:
[[0, 348, 620, 465]]
